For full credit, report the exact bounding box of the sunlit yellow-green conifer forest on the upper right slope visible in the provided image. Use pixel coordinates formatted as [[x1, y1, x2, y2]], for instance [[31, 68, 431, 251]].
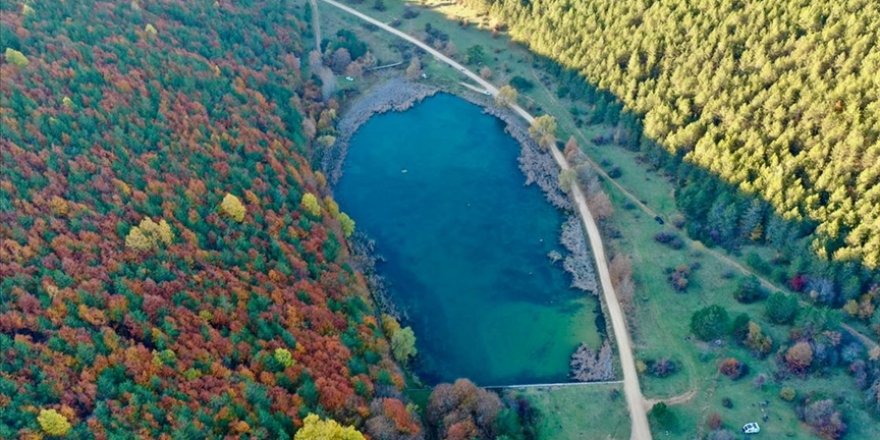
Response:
[[458, 0, 880, 270]]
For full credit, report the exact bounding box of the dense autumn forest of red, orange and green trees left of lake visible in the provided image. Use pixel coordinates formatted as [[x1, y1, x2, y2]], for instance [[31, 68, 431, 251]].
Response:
[[0, 0, 420, 438]]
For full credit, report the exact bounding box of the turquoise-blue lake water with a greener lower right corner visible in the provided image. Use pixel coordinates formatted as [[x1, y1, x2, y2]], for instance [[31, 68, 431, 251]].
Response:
[[335, 94, 599, 385]]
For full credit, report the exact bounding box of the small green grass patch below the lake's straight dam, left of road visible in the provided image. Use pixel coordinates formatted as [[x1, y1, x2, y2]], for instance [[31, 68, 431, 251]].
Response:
[[512, 384, 630, 440]]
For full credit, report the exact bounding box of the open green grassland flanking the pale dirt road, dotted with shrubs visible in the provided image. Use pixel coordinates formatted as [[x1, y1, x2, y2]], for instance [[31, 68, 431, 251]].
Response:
[[321, 0, 880, 439]]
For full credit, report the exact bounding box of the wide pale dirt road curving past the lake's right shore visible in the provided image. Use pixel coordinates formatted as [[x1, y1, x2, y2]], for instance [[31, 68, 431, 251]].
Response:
[[313, 0, 652, 440]]
